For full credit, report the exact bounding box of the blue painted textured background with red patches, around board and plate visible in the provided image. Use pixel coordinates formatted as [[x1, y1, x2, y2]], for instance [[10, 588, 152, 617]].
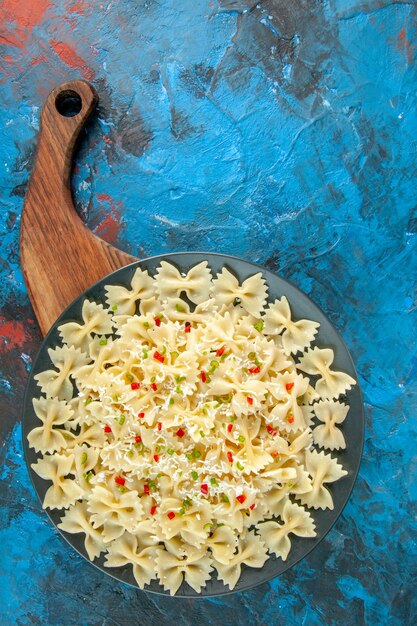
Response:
[[0, 0, 417, 626]]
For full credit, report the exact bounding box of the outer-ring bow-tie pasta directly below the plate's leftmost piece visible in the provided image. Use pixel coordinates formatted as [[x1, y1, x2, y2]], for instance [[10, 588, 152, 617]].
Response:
[[31, 453, 83, 509]]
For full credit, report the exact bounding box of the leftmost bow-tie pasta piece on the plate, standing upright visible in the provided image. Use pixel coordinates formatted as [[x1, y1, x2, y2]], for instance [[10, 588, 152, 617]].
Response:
[[28, 398, 73, 454]]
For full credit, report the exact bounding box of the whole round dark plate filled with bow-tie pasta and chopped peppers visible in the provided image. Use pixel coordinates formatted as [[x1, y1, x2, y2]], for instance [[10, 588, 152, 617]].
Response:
[[23, 253, 364, 597]]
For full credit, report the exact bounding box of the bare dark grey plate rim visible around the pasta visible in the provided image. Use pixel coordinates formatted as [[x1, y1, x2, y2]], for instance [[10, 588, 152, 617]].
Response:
[[23, 252, 364, 597]]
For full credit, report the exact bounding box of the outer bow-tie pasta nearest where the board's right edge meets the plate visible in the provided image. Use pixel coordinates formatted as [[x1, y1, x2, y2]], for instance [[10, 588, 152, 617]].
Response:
[[105, 267, 155, 315]]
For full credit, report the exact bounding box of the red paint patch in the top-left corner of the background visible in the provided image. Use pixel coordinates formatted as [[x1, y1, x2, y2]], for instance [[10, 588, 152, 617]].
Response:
[[0, 0, 50, 48]]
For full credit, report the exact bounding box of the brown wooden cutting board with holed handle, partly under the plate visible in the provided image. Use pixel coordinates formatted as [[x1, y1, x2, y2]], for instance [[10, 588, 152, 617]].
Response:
[[20, 80, 136, 335]]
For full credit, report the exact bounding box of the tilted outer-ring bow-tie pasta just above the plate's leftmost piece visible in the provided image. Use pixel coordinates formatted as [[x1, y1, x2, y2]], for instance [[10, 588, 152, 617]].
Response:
[[34, 346, 89, 400]]
